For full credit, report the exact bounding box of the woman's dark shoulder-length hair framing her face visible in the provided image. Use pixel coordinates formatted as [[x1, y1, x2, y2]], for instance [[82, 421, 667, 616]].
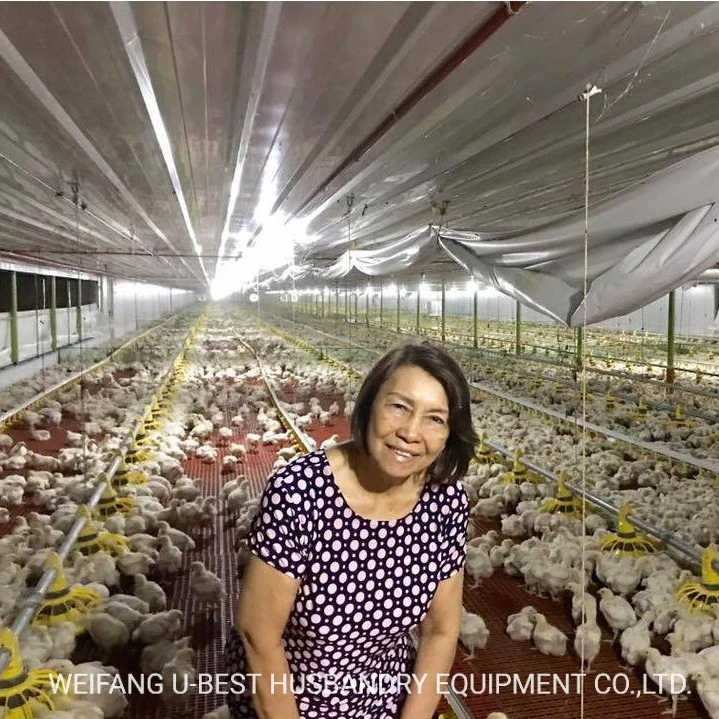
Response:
[[350, 340, 479, 484]]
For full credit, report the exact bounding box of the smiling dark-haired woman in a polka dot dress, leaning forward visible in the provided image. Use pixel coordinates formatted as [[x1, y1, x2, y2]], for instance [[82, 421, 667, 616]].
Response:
[[227, 342, 477, 719]]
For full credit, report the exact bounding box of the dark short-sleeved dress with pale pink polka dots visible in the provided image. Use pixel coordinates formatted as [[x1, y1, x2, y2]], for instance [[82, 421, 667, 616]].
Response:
[[226, 450, 469, 719]]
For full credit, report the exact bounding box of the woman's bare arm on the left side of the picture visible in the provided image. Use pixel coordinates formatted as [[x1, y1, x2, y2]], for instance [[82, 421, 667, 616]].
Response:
[[237, 556, 300, 719]]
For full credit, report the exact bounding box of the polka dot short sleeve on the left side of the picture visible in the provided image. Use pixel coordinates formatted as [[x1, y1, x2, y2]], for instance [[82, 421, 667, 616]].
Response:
[[248, 461, 311, 579]]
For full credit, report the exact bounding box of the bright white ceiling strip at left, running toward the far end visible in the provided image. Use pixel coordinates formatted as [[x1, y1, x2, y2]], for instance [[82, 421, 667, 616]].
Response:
[[110, 1, 210, 285]]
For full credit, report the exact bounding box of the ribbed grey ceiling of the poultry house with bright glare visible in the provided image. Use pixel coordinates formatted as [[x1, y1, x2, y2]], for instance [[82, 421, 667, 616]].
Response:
[[0, 2, 719, 290]]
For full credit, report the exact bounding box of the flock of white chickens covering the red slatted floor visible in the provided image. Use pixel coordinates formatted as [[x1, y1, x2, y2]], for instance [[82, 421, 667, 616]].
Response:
[[0, 304, 719, 719]]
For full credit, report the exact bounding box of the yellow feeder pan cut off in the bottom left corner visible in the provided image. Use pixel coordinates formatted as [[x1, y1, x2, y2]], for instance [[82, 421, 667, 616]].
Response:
[[0, 627, 58, 719]]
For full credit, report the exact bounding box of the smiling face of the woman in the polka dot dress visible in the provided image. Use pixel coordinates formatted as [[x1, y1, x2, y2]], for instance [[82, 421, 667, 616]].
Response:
[[367, 365, 449, 478]]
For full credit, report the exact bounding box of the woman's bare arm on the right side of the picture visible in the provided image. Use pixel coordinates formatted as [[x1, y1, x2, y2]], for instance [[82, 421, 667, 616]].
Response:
[[400, 571, 464, 719]]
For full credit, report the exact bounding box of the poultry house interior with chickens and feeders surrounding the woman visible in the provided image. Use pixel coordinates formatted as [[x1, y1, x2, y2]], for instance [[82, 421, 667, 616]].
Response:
[[0, 0, 719, 719]]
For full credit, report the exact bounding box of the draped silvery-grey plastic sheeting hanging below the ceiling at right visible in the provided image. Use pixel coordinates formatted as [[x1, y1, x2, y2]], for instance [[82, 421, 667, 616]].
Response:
[[306, 148, 719, 326]]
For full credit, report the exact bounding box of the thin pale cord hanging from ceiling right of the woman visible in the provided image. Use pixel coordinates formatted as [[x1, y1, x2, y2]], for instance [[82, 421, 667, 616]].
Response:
[[575, 84, 601, 719]]
